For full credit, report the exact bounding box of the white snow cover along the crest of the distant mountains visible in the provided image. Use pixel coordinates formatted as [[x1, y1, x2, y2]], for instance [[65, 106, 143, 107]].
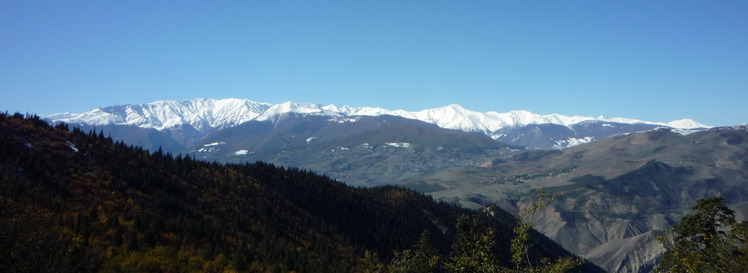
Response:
[[45, 98, 710, 135]]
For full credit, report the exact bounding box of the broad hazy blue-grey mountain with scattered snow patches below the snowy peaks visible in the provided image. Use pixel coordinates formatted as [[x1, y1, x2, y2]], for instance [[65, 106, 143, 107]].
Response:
[[190, 115, 510, 186]]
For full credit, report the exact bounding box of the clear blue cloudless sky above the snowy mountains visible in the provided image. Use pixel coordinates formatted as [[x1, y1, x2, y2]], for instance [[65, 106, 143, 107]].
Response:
[[0, 0, 748, 125]]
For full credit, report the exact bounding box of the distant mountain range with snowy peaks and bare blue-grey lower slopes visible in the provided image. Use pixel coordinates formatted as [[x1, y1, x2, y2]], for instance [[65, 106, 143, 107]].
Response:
[[45, 99, 710, 152]]
